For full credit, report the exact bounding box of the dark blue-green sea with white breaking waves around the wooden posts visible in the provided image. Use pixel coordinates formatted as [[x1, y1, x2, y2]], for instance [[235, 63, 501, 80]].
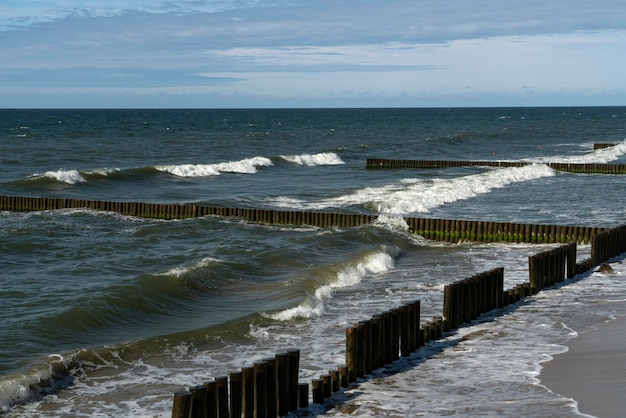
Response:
[[0, 107, 626, 418]]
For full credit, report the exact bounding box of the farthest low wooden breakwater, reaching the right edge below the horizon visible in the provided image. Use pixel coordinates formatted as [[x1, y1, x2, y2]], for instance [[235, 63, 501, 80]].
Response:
[[365, 158, 626, 174]]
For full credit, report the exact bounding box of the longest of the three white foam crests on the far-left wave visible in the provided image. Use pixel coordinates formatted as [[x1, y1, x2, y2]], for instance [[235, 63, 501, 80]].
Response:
[[154, 157, 274, 177]]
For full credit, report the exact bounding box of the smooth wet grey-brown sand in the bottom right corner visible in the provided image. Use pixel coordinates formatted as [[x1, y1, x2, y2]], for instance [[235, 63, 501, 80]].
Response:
[[539, 318, 626, 418]]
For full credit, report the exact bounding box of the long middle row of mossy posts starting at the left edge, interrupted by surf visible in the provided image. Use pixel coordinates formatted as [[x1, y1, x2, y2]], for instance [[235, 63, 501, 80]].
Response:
[[0, 196, 604, 244]]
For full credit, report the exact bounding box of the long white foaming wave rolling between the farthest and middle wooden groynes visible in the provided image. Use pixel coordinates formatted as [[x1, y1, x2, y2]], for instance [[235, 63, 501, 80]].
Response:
[[272, 164, 555, 215]]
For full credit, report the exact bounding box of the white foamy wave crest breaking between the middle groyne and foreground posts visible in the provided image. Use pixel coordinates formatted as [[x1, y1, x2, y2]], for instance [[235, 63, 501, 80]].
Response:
[[264, 248, 399, 321]]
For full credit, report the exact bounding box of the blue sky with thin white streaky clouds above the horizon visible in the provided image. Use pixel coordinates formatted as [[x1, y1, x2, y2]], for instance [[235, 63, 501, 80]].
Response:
[[0, 0, 626, 108]]
